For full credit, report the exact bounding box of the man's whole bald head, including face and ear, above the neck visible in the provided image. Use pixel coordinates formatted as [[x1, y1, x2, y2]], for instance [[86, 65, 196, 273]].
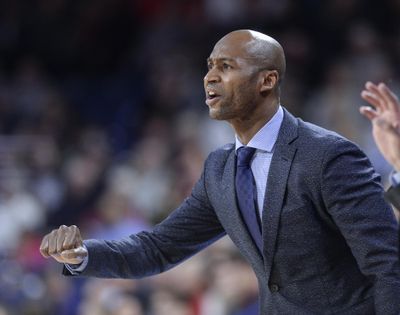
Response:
[[204, 30, 285, 123]]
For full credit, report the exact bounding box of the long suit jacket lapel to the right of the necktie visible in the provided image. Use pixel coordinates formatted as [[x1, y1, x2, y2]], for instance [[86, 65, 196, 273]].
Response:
[[262, 110, 297, 277]]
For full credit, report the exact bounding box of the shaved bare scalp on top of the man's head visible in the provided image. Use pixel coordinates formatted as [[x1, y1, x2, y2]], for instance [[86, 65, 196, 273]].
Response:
[[214, 30, 286, 82]]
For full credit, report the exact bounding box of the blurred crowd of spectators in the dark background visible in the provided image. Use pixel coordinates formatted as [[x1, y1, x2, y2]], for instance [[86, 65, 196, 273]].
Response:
[[0, 0, 400, 315]]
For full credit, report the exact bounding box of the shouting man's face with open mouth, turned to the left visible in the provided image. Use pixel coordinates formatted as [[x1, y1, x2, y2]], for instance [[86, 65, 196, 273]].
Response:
[[204, 38, 259, 121]]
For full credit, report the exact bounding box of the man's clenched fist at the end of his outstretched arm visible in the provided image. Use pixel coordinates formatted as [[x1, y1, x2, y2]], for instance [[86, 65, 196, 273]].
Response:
[[40, 225, 88, 265]]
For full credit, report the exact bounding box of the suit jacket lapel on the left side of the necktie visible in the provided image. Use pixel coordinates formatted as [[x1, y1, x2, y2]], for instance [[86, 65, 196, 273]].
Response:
[[222, 149, 263, 266]]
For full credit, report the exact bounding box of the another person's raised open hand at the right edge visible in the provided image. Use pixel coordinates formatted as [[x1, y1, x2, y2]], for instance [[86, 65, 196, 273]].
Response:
[[360, 82, 400, 171]]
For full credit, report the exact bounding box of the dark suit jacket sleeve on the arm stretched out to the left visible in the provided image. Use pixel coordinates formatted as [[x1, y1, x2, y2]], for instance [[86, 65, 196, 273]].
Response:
[[63, 160, 225, 278]]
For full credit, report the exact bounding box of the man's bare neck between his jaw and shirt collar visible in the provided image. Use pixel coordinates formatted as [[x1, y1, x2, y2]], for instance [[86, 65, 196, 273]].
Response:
[[229, 100, 279, 145]]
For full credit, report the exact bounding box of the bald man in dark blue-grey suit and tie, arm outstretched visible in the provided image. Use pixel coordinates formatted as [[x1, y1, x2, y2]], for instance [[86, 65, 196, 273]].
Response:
[[41, 30, 400, 315]]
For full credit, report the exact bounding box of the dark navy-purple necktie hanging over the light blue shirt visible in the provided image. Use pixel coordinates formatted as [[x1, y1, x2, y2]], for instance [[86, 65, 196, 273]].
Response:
[[236, 147, 262, 253]]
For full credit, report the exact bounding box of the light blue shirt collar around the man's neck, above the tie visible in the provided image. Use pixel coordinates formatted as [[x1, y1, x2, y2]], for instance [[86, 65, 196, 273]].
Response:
[[235, 106, 283, 152]]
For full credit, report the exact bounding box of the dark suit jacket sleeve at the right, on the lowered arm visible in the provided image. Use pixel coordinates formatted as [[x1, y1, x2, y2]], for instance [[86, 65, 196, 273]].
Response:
[[321, 139, 400, 315]]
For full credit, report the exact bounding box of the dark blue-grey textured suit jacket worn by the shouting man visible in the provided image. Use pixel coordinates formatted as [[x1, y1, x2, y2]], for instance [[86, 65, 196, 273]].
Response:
[[64, 111, 400, 315]]
